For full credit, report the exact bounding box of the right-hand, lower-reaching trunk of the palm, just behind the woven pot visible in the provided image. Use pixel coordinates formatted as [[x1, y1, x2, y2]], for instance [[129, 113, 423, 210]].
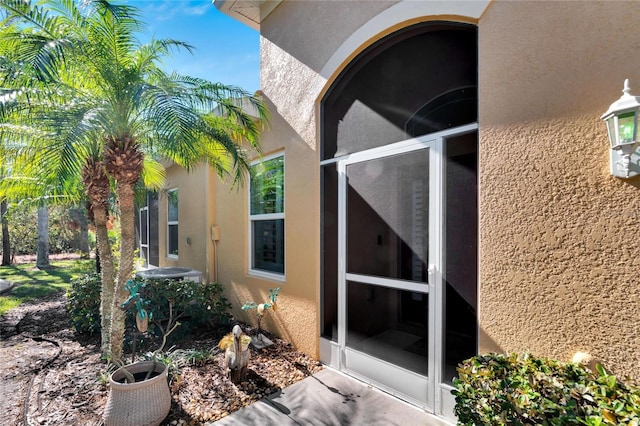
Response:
[[110, 181, 136, 359]]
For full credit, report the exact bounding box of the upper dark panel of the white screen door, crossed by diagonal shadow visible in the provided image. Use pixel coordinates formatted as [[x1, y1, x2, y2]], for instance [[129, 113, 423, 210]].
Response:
[[346, 149, 430, 283]]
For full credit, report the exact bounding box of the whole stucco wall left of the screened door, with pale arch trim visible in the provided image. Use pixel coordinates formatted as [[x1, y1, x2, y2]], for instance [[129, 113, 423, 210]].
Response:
[[235, 1, 484, 356]]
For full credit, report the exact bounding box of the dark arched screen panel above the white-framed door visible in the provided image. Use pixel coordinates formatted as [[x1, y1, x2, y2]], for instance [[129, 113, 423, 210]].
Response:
[[320, 21, 478, 160]]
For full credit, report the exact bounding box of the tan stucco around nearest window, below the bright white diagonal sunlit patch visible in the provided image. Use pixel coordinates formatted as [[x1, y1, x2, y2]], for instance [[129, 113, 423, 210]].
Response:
[[215, 97, 319, 356]]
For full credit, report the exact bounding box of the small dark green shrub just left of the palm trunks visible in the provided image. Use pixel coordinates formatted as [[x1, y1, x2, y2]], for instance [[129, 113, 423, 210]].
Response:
[[67, 273, 101, 334]]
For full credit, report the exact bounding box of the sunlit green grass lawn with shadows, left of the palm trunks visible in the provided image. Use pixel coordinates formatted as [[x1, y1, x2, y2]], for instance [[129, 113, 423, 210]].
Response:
[[0, 260, 95, 315]]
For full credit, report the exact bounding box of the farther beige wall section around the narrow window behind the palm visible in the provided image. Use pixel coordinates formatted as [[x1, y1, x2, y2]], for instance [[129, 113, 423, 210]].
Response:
[[158, 164, 214, 282]]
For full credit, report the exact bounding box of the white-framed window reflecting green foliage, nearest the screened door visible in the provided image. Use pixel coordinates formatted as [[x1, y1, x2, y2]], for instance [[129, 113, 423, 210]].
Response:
[[249, 154, 284, 279]]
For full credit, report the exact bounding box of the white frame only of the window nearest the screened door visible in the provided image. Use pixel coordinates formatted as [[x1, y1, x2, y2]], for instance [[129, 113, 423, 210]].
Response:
[[247, 152, 287, 282]]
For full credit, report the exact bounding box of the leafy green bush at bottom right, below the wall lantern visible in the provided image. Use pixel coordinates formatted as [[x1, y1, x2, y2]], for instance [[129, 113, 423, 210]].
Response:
[[452, 354, 640, 426]]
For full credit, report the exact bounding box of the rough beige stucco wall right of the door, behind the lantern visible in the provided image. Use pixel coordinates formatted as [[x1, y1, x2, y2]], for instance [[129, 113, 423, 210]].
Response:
[[479, 1, 640, 380]]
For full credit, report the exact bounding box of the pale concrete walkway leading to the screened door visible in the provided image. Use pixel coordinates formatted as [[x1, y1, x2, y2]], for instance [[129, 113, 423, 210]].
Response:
[[207, 368, 450, 426]]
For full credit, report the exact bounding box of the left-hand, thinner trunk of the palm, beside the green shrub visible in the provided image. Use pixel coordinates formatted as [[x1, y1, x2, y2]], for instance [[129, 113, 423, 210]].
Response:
[[93, 206, 116, 357]]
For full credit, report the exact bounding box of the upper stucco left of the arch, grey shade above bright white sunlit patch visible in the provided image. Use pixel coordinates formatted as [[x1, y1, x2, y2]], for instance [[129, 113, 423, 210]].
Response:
[[260, 1, 396, 149]]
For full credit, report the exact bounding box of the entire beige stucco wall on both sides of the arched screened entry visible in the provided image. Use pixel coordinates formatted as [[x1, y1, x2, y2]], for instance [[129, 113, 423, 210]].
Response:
[[211, 1, 640, 379]]
